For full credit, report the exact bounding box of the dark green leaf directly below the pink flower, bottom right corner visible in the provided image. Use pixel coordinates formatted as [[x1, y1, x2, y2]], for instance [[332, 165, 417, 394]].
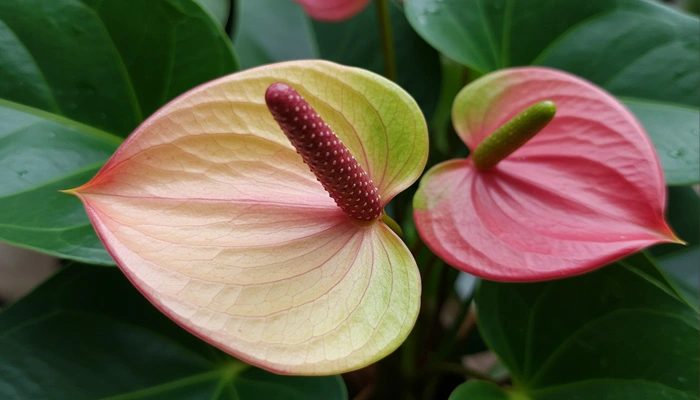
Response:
[[477, 254, 698, 400]]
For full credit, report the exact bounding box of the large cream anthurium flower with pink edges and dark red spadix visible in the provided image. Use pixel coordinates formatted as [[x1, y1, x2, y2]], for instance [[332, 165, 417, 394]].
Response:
[[67, 61, 427, 375]]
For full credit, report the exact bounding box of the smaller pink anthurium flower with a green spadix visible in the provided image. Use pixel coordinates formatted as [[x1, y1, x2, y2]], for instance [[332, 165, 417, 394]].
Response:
[[414, 67, 677, 281]]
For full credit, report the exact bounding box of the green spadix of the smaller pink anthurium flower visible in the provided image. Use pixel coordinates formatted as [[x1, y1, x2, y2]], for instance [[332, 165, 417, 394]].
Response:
[[472, 100, 557, 169]]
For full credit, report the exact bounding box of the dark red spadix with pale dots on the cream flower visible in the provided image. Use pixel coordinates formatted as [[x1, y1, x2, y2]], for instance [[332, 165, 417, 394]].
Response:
[[265, 82, 382, 221]]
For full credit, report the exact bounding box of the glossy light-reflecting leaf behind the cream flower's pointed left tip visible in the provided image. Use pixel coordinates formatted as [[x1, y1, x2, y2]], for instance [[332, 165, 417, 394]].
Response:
[[0, 100, 121, 264]]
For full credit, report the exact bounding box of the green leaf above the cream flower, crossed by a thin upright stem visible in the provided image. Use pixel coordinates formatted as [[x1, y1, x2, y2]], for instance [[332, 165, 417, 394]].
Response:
[[235, 0, 441, 118]]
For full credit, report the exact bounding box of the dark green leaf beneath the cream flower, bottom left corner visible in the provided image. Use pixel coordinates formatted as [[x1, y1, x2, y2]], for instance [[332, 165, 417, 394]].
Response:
[[0, 265, 347, 400]]
